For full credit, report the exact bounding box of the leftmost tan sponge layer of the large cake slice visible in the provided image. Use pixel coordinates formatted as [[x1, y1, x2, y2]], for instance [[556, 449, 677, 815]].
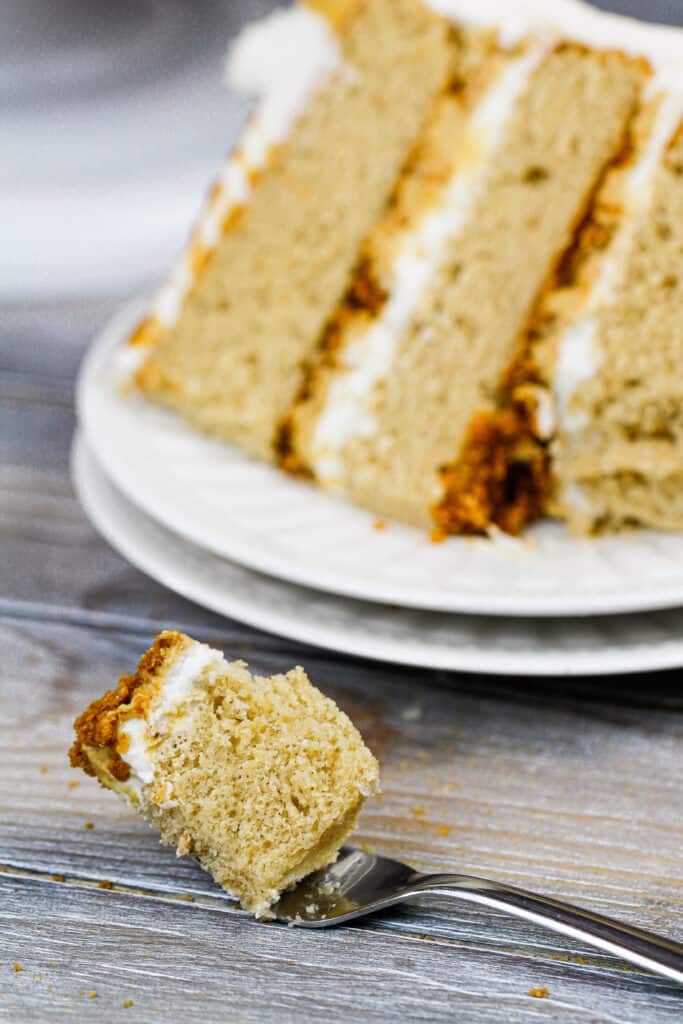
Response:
[[137, 0, 454, 459]]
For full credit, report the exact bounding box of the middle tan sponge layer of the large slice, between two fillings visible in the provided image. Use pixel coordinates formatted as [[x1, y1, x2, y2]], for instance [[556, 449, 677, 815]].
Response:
[[290, 43, 645, 531]]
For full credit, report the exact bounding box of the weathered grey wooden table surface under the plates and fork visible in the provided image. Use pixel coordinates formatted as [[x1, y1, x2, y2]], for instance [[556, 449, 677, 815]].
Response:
[[0, 304, 683, 1024]]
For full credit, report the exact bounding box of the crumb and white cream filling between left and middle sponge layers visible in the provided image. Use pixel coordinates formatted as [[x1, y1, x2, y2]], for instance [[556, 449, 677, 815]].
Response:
[[281, 33, 528, 481]]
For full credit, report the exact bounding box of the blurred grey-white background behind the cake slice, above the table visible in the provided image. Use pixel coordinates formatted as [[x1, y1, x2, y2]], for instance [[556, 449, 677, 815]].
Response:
[[0, 0, 683, 306]]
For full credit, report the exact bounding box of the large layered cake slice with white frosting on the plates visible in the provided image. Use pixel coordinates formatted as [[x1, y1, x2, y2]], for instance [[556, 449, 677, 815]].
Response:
[[133, 0, 683, 538]]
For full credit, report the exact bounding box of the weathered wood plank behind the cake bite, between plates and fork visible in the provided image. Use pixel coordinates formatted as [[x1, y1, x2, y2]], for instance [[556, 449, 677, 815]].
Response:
[[0, 620, 683, 954]]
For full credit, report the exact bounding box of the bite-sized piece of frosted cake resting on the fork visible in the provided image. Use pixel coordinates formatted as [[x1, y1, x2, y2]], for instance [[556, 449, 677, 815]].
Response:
[[71, 632, 379, 916]]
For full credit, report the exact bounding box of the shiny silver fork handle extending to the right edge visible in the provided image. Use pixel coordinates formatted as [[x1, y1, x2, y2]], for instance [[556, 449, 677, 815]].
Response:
[[411, 874, 683, 983]]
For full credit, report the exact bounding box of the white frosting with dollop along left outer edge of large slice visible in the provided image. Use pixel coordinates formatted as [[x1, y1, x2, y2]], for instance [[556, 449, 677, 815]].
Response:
[[152, 5, 341, 327]]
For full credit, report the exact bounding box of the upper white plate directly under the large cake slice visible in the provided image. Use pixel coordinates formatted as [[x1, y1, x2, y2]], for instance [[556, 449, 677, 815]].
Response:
[[78, 296, 683, 615]]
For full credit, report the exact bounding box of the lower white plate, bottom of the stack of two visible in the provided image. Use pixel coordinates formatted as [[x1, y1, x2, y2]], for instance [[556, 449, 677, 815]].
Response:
[[73, 436, 683, 676]]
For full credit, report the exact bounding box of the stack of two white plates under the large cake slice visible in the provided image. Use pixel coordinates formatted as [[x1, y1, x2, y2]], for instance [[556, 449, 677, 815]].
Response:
[[74, 305, 683, 675]]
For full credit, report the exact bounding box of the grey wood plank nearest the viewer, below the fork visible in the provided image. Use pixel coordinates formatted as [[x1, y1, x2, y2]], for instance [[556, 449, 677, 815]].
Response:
[[0, 876, 683, 1024]]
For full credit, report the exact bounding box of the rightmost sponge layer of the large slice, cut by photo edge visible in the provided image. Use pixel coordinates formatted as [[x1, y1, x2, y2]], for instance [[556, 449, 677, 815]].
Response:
[[545, 96, 683, 532]]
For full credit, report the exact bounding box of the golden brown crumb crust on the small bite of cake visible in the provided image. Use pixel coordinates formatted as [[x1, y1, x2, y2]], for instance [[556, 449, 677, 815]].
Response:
[[69, 630, 191, 781]]
